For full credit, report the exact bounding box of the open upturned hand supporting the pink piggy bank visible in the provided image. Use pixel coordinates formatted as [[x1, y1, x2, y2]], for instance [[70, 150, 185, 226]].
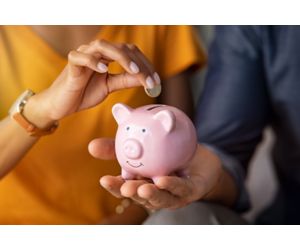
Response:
[[89, 138, 236, 210]]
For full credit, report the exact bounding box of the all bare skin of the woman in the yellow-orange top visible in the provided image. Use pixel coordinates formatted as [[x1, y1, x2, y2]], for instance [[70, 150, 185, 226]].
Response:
[[0, 26, 193, 224]]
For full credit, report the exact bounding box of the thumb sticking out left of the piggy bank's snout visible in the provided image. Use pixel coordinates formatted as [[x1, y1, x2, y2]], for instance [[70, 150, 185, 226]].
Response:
[[88, 138, 116, 160]]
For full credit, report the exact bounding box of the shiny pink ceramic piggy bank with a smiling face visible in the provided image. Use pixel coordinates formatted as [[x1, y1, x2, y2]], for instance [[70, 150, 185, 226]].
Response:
[[112, 103, 197, 180]]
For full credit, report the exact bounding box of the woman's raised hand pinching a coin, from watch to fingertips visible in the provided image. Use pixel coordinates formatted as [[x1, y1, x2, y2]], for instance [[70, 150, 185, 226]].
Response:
[[24, 40, 160, 127]]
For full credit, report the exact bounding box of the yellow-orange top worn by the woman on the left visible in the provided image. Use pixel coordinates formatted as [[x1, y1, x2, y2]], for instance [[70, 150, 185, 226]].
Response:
[[0, 26, 205, 224]]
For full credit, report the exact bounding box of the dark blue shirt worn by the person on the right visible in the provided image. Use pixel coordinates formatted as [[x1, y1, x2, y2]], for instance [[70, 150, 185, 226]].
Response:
[[196, 26, 300, 224]]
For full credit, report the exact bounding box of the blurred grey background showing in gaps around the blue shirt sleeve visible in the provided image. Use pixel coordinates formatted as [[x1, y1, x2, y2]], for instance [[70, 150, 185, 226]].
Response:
[[191, 25, 278, 221]]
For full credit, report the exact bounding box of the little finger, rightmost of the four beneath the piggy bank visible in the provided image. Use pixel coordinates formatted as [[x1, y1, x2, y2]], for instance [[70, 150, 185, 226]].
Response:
[[155, 176, 195, 197]]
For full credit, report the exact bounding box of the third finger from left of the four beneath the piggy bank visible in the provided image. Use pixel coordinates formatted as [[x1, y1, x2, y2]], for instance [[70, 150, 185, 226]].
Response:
[[138, 184, 181, 208]]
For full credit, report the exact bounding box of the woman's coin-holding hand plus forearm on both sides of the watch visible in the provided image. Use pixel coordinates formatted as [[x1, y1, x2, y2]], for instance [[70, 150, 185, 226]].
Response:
[[0, 37, 159, 177]]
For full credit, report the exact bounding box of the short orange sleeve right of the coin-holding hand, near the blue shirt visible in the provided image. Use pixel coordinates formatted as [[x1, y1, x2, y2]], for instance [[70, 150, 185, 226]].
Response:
[[157, 25, 206, 79]]
